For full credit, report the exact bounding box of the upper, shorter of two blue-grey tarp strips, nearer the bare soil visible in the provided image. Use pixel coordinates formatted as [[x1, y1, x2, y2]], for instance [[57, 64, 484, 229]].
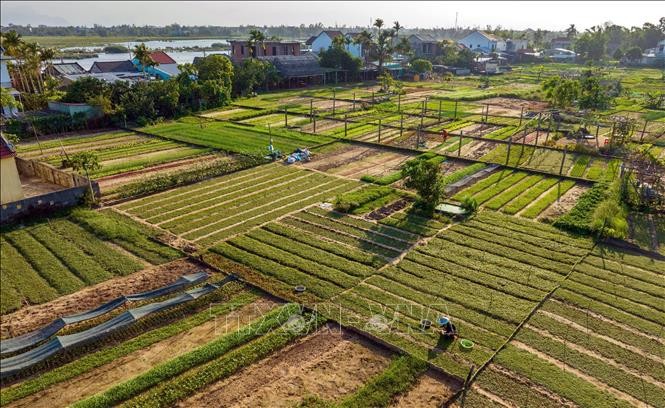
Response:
[[0, 272, 208, 354]]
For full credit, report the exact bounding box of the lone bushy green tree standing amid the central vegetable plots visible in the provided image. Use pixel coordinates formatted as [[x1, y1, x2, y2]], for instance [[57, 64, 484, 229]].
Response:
[[402, 159, 443, 211]]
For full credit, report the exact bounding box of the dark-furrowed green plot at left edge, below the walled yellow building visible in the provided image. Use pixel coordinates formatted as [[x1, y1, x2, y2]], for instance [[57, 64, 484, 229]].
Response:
[[0, 211, 180, 314]]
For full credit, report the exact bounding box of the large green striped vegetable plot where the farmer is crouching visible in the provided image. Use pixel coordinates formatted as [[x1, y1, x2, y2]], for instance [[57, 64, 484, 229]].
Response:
[[329, 212, 590, 378]]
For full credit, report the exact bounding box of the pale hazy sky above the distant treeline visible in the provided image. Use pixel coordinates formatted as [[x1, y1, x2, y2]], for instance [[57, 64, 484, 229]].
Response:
[[0, 0, 665, 30]]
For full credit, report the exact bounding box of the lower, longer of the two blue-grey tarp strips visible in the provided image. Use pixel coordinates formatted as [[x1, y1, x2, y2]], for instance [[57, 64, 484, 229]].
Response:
[[0, 275, 236, 378]]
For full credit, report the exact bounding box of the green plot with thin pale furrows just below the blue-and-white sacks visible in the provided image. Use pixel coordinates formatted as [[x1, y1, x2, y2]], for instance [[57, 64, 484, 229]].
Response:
[[120, 165, 359, 246]]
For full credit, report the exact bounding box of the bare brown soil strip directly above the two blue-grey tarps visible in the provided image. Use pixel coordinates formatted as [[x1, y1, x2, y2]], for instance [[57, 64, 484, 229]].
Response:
[[0, 259, 212, 338]]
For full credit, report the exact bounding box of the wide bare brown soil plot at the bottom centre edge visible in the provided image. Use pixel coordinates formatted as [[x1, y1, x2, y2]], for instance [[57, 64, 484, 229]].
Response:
[[178, 325, 390, 407]]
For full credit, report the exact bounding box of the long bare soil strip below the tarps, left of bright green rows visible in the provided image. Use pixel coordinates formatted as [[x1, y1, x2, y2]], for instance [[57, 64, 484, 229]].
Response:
[[9, 299, 277, 408]]
